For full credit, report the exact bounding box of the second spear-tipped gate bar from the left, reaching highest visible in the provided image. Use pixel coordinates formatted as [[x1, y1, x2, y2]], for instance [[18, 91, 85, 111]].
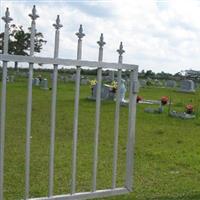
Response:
[[25, 6, 39, 199]]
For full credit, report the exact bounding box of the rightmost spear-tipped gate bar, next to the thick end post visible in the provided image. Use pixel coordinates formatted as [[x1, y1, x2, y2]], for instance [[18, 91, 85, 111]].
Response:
[[112, 42, 125, 189]]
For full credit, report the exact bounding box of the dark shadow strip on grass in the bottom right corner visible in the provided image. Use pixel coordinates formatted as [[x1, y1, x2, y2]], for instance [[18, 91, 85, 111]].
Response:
[[147, 192, 200, 200]]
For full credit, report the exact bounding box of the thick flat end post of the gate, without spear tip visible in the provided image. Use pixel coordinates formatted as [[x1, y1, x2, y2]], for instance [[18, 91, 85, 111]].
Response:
[[125, 69, 138, 191]]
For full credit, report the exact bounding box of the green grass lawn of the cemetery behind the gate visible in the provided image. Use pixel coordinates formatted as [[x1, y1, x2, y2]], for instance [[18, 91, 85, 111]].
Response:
[[0, 76, 200, 200]]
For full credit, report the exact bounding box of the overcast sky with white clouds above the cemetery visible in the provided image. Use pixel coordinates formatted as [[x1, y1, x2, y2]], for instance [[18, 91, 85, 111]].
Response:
[[0, 0, 200, 73]]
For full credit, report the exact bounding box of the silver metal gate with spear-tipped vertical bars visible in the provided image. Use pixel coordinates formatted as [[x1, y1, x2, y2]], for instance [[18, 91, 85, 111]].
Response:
[[0, 6, 138, 200]]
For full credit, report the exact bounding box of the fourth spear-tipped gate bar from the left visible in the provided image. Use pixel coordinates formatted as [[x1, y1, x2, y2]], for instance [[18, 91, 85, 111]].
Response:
[[71, 25, 85, 194]]
